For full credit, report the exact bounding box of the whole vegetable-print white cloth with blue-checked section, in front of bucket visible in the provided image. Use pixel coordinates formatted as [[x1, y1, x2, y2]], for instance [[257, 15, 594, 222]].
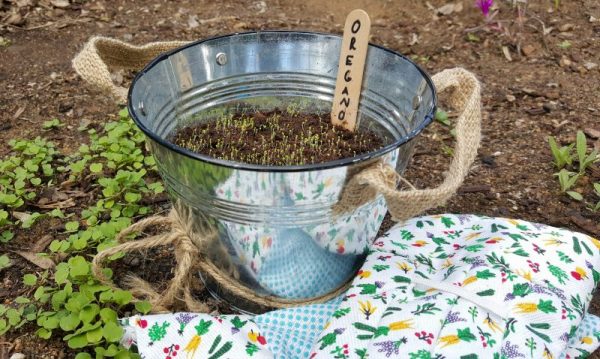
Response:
[[123, 215, 600, 359]]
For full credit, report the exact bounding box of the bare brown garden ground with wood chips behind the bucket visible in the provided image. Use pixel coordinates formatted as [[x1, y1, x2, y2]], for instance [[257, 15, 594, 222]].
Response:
[[0, 0, 600, 358]]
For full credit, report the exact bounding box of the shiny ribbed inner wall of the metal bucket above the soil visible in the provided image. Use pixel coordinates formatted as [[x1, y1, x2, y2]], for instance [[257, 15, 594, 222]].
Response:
[[129, 31, 436, 171]]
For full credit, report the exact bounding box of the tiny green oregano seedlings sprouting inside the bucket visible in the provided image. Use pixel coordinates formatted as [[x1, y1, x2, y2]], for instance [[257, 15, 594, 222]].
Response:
[[172, 103, 382, 166]]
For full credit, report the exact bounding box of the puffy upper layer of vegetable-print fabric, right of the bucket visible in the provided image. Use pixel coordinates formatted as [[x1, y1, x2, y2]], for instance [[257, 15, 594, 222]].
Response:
[[313, 215, 600, 359]]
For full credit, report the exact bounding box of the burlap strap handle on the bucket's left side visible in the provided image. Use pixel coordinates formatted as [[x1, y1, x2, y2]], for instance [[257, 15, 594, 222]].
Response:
[[73, 36, 188, 104]]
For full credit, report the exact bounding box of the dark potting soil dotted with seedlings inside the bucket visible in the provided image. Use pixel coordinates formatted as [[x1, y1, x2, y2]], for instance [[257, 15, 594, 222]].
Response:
[[171, 110, 384, 166]]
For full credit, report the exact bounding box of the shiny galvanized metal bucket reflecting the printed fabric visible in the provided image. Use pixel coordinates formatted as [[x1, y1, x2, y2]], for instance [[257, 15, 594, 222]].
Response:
[[128, 31, 436, 311]]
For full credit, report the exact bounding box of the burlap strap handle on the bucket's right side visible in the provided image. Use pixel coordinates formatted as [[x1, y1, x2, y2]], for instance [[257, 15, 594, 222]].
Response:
[[337, 68, 481, 221]]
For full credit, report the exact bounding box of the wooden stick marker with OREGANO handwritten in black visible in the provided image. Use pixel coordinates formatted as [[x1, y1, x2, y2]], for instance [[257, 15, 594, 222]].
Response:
[[331, 9, 371, 131]]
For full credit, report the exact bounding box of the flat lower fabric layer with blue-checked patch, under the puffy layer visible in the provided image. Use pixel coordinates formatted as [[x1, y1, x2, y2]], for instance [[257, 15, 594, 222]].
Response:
[[122, 314, 600, 359]]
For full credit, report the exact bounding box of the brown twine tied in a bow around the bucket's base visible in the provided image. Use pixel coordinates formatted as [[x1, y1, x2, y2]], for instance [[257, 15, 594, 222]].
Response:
[[92, 209, 350, 313]]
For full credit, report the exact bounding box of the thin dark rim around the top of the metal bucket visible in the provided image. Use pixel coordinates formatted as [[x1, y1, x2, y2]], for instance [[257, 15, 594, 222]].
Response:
[[127, 30, 437, 172]]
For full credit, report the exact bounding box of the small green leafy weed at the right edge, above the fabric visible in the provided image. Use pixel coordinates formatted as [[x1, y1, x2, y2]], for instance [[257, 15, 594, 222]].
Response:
[[548, 131, 600, 212]]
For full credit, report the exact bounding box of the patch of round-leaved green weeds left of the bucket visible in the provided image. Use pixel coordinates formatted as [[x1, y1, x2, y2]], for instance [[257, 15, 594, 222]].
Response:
[[0, 110, 164, 359]]
